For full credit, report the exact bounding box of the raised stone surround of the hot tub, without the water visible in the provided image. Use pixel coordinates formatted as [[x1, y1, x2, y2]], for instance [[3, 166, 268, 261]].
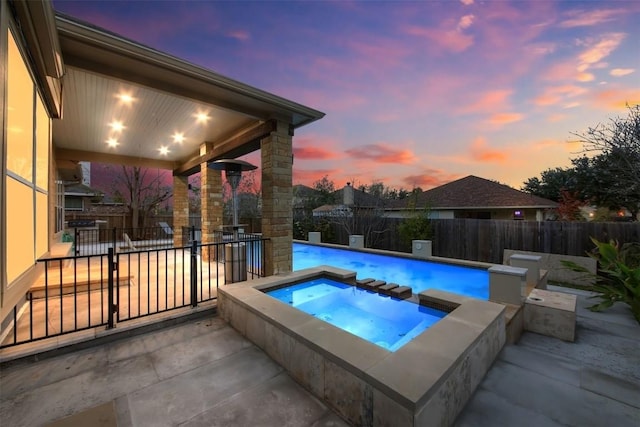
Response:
[[218, 266, 505, 426]]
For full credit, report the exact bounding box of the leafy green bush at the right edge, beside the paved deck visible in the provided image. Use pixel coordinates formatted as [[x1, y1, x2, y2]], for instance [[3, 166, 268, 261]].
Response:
[[562, 238, 640, 323]]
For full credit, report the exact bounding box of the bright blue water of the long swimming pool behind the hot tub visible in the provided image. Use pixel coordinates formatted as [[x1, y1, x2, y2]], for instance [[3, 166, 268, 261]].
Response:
[[293, 243, 489, 300]]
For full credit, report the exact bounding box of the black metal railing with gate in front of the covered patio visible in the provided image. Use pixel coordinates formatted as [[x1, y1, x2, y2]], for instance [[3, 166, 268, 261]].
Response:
[[0, 236, 266, 348]]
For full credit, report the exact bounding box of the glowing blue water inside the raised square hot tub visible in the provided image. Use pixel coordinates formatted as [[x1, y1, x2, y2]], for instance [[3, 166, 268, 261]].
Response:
[[267, 278, 447, 351]]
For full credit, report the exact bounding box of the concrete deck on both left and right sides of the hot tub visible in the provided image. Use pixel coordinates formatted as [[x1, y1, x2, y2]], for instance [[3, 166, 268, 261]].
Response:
[[0, 288, 640, 427]]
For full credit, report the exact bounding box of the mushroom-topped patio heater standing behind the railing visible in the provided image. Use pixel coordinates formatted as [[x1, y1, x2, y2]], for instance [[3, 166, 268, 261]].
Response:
[[207, 159, 257, 283]]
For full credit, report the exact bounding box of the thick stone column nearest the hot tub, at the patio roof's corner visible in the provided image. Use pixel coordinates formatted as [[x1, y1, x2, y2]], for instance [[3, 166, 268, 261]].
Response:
[[260, 122, 293, 276]]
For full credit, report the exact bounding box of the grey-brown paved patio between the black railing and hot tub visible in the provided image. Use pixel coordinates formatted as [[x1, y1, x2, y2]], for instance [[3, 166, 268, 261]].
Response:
[[0, 315, 347, 427]]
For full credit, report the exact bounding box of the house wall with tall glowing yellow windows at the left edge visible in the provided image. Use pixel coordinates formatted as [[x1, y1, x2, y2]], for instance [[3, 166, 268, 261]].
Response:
[[0, 0, 55, 321]]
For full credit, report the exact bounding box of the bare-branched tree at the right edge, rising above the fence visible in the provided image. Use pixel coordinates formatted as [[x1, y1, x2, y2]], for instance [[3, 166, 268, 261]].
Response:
[[573, 105, 640, 220]]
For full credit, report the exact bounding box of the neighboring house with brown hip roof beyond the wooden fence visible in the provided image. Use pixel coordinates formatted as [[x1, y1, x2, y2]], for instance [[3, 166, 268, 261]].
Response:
[[385, 175, 558, 221]]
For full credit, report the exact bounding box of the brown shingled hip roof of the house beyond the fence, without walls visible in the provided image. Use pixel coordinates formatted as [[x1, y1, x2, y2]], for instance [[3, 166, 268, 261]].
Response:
[[394, 175, 558, 209]]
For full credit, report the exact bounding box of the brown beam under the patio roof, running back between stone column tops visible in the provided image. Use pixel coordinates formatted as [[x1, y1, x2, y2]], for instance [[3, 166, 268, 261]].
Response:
[[173, 120, 277, 176]]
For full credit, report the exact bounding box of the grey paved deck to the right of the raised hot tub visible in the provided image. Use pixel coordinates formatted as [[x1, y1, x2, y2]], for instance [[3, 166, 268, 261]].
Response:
[[456, 287, 640, 427]]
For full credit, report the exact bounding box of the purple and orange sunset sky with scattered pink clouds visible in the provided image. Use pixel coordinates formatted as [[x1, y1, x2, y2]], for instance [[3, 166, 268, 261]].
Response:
[[54, 0, 640, 189]]
